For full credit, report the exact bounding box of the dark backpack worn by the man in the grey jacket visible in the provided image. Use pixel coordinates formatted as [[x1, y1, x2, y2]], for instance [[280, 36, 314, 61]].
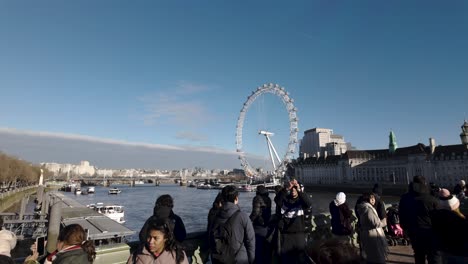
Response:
[[210, 210, 243, 264]]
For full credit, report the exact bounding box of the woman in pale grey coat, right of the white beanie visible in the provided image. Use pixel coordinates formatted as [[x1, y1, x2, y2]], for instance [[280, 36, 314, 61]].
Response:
[[357, 193, 388, 264]]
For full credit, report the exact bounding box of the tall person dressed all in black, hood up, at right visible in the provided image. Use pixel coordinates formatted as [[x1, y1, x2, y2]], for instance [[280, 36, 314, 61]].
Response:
[[398, 176, 442, 264]]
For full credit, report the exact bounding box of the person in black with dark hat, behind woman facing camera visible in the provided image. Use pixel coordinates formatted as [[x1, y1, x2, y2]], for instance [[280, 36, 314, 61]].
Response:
[[139, 194, 187, 243]]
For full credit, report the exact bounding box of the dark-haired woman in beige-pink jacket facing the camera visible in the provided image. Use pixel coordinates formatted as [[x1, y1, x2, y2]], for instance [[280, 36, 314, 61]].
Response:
[[127, 218, 188, 264]]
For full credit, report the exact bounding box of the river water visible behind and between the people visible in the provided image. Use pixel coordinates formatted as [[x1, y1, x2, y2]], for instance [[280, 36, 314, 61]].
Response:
[[64, 184, 398, 240]]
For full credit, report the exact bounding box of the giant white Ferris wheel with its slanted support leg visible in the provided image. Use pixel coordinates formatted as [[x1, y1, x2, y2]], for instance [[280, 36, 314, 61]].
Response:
[[236, 83, 299, 178]]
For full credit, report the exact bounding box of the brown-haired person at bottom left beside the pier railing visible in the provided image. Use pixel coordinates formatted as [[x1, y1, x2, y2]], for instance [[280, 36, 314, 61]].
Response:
[[44, 224, 96, 264]]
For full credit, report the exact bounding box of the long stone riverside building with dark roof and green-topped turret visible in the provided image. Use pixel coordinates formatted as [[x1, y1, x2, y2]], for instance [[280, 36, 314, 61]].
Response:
[[292, 121, 468, 190]]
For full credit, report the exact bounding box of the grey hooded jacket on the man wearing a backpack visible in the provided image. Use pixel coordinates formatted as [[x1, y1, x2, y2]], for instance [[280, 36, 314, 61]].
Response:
[[210, 202, 255, 264]]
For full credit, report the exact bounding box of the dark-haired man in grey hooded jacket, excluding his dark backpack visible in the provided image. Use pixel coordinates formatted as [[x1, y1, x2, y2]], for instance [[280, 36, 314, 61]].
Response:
[[209, 185, 255, 264]]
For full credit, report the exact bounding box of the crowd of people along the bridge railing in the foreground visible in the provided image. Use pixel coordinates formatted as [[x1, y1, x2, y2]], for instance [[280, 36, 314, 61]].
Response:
[[0, 176, 468, 264]]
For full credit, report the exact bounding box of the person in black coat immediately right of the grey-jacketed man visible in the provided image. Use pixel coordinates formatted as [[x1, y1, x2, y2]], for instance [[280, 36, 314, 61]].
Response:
[[250, 185, 271, 263]]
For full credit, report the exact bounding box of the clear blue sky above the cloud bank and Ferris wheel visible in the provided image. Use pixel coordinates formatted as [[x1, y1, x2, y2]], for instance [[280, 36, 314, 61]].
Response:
[[0, 0, 468, 167]]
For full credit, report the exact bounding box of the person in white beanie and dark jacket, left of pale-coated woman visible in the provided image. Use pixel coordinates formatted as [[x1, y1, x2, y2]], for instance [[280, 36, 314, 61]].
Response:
[[329, 192, 356, 242]]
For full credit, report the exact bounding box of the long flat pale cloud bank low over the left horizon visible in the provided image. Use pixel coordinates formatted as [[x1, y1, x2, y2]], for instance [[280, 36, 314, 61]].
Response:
[[0, 127, 270, 169]]
